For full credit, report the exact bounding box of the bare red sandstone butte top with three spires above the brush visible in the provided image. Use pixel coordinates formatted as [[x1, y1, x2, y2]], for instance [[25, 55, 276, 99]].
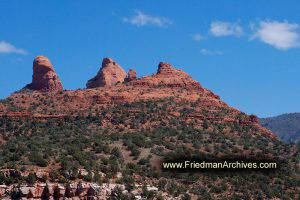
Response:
[[0, 56, 272, 134]]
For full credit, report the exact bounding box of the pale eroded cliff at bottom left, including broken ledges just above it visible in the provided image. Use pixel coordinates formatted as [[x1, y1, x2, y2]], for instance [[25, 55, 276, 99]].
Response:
[[0, 167, 164, 200]]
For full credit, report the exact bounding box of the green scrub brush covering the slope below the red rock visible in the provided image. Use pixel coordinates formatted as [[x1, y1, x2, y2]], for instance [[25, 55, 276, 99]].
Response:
[[0, 99, 300, 199]]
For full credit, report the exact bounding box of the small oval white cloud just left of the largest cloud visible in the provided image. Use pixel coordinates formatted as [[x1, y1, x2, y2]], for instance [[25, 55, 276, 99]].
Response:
[[210, 21, 243, 37]]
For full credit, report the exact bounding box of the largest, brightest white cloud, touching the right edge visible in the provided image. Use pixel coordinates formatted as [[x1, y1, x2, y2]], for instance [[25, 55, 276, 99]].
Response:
[[250, 20, 300, 50]]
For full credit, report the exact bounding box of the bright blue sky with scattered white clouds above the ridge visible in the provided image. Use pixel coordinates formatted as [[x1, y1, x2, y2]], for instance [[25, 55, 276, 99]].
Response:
[[0, 0, 300, 117]]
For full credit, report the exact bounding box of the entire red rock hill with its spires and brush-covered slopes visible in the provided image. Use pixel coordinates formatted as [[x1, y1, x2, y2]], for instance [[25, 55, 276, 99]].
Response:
[[0, 57, 300, 200]]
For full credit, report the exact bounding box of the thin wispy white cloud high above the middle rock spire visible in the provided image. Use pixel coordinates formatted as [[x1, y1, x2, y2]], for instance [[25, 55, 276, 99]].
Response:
[[123, 10, 173, 27]]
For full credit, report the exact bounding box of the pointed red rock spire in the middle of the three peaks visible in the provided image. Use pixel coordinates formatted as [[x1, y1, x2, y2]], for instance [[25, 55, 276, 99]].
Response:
[[86, 58, 126, 88]]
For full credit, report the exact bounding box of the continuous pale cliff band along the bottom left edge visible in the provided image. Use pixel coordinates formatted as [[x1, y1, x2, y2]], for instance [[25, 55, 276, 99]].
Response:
[[0, 182, 165, 200]]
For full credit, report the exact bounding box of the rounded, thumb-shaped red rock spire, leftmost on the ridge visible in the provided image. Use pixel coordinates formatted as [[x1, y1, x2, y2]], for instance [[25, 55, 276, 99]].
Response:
[[25, 56, 63, 92]]
